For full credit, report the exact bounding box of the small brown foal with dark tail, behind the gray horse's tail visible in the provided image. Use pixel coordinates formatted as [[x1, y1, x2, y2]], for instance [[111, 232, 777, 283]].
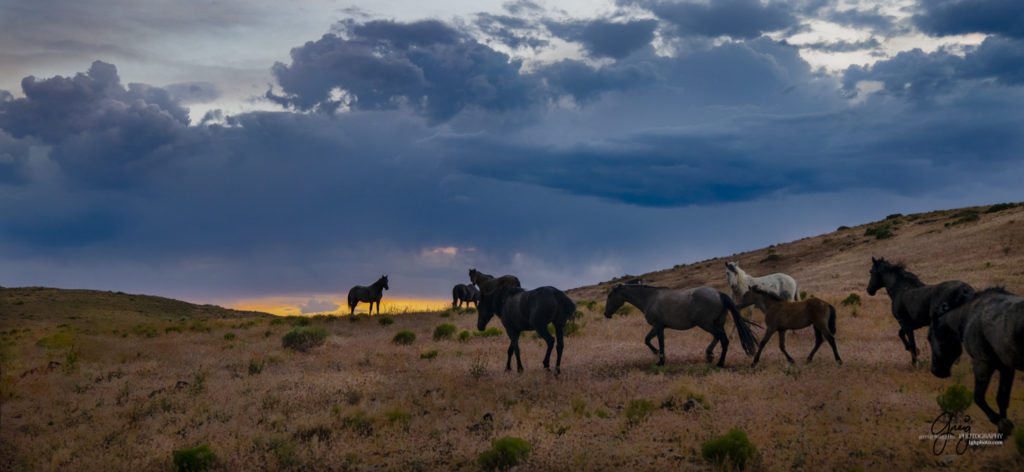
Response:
[[743, 287, 843, 367]]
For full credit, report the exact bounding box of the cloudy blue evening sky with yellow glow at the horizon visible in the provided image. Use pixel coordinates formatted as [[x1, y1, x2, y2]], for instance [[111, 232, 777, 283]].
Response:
[[0, 0, 1024, 313]]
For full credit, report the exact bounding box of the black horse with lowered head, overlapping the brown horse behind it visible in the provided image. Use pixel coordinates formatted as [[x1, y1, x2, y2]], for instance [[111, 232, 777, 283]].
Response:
[[476, 286, 575, 375]]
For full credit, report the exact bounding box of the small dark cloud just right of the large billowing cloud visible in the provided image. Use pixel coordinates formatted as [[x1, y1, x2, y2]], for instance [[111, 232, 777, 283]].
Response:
[[547, 19, 657, 59]]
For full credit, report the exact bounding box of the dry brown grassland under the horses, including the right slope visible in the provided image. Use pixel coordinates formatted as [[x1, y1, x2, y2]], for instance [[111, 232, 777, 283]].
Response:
[[0, 206, 1024, 471]]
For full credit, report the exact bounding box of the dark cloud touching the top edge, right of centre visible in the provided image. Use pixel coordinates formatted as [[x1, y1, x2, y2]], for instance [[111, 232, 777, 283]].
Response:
[[620, 0, 800, 39]]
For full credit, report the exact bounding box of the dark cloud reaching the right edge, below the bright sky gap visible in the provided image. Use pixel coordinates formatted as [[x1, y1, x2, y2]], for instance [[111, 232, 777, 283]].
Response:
[[843, 37, 1024, 100]]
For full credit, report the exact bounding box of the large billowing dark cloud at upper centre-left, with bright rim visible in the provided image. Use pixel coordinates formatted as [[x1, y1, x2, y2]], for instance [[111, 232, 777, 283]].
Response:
[[267, 20, 536, 122]]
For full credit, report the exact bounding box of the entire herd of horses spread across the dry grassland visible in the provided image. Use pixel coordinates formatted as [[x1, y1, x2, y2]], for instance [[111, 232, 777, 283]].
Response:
[[348, 257, 1024, 437]]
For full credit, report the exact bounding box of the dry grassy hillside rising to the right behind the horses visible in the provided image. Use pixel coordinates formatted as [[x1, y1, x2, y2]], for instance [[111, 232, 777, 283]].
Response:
[[567, 203, 1024, 302]]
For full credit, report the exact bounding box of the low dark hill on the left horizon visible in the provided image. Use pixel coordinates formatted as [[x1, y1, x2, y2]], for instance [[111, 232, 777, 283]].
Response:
[[0, 287, 272, 330]]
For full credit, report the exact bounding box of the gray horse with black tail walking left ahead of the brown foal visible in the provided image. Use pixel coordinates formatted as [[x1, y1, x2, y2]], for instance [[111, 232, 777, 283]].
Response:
[[604, 284, 758, 367]]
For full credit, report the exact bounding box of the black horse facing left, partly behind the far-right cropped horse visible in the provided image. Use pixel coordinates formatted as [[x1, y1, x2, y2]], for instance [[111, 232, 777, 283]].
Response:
[[867, 257, 974, 364]]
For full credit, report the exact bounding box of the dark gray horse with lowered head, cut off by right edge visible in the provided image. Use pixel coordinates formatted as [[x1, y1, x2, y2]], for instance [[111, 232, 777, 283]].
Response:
[[928, 288, 1024, 437]]
